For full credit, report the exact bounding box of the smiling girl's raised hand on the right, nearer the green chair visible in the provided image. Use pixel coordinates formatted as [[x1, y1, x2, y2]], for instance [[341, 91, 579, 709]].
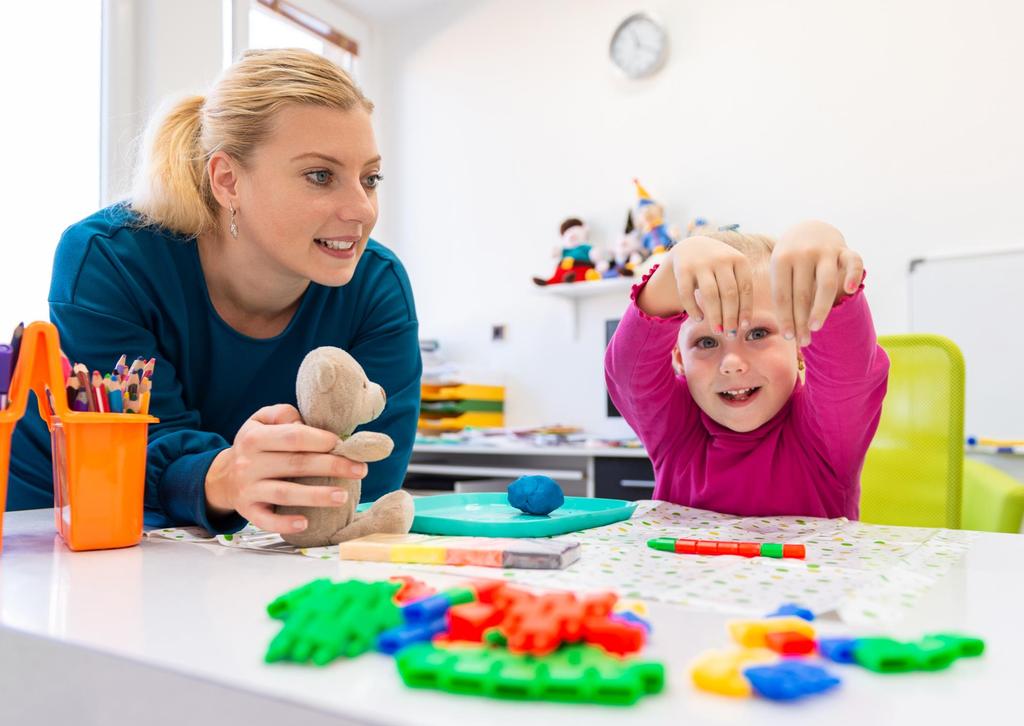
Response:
[[771, 221, 864, 346]]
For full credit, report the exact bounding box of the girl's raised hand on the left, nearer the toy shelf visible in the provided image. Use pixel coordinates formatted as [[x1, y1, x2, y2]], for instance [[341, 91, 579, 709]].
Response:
[[637, 236, 754, 336]]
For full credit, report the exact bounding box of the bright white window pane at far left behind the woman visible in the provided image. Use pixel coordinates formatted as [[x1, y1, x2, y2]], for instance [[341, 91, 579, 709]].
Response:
[[0, 0, 102, 323]]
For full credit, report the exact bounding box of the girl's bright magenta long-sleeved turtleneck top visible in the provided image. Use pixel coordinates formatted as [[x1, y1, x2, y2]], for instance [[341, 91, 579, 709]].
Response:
[[604, 269, 889, 519]]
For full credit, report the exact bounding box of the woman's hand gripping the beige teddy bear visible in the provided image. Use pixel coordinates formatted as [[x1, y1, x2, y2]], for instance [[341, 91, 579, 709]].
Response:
[[206, 403, 367, 532]]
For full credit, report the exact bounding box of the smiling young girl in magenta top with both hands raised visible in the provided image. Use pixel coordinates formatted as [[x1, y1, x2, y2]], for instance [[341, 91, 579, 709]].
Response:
[[605, 221, 889, 518]]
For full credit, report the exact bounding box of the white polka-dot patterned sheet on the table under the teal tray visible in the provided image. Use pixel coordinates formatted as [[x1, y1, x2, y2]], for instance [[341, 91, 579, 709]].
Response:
[[146, 501, 972, 625]]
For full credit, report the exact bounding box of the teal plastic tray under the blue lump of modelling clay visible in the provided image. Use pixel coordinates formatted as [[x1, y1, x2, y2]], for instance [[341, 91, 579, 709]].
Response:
[[405, 492, 637, 537]]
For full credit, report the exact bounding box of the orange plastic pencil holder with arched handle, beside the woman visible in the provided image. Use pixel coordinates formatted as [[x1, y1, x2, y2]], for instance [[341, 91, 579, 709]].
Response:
[[0, 323, 158, 550]]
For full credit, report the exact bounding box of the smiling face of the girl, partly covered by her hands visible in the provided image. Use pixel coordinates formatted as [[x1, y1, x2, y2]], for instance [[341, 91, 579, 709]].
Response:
[[673, 272, 797, 432]]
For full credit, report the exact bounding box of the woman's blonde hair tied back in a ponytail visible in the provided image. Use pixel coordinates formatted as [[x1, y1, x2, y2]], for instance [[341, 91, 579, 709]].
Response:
[[131, 49, 374, 238]]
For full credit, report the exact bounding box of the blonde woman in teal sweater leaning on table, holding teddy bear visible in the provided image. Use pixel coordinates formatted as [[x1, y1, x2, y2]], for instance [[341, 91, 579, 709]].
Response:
[[7, 50, 422, 532]]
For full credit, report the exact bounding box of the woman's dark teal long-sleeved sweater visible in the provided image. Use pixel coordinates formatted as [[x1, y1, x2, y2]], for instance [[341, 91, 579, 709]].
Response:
[[7, 205, 422, 532]]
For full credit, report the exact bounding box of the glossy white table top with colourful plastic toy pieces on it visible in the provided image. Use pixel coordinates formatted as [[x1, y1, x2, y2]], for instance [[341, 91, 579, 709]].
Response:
[[0, 510, 1024, 726]]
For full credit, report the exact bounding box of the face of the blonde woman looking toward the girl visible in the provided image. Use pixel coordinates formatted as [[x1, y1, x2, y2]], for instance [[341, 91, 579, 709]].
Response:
[[237, 104, 381, 287]]
